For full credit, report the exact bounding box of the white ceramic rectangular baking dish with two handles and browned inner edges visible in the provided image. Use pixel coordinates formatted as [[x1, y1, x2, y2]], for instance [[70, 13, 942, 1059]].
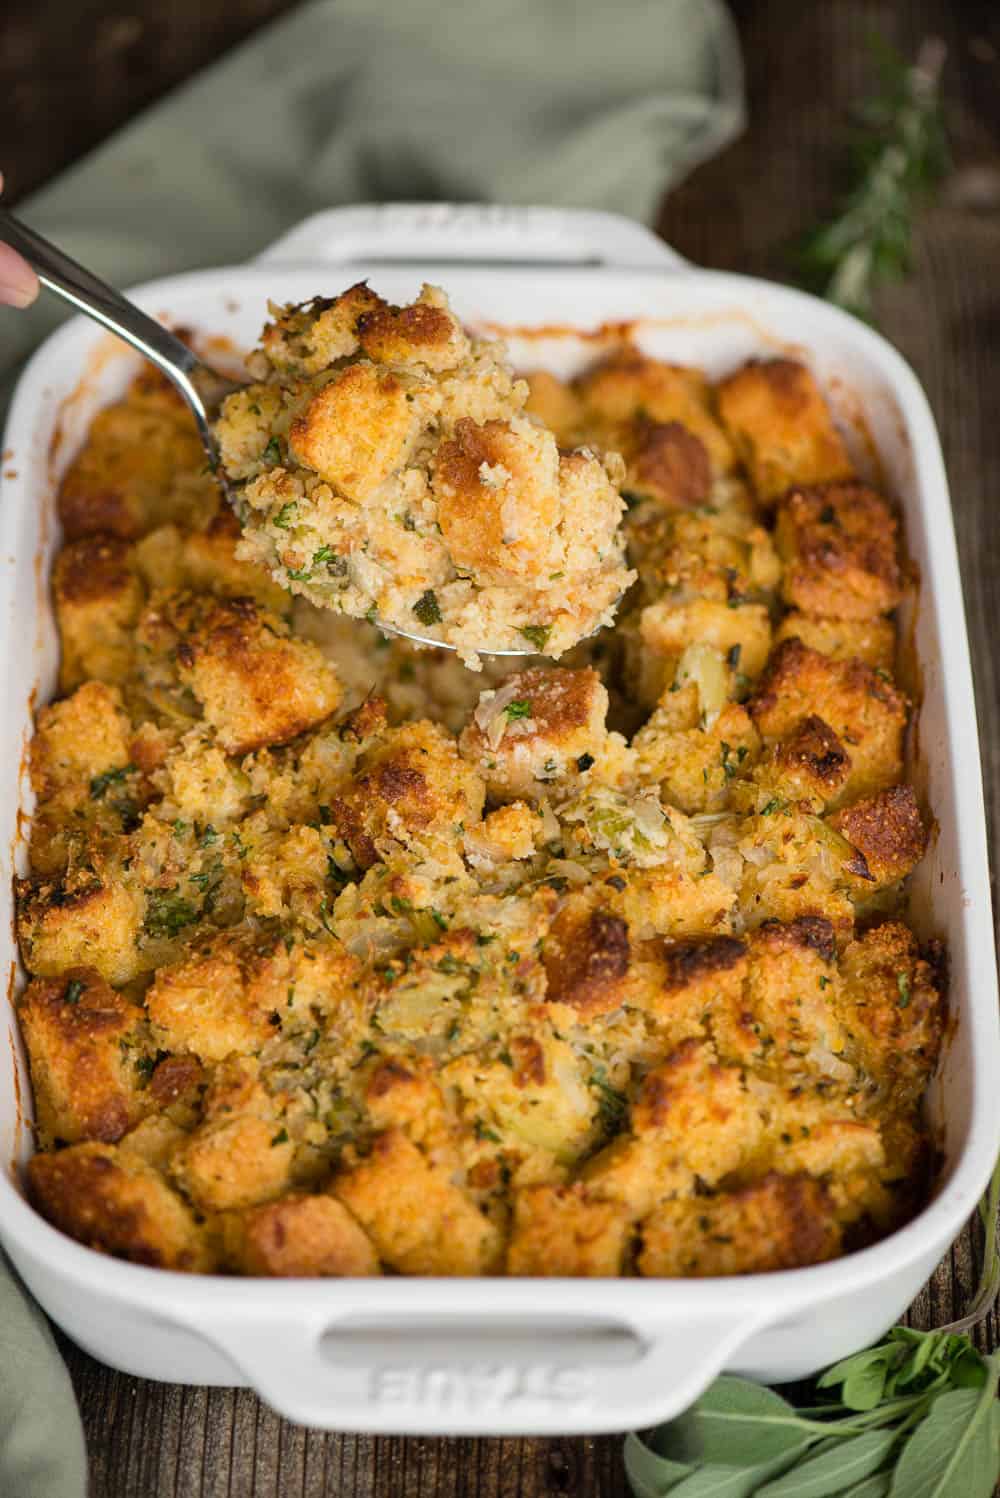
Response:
[[0, 205, 1000, 1435]]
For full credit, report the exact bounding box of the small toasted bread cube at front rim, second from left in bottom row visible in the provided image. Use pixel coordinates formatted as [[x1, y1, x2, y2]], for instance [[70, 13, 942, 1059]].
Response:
[[225, 1192, 379, 1278]]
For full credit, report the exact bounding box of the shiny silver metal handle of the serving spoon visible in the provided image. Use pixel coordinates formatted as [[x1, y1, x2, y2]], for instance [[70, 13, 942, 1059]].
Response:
[[0, 208, 214, 445]]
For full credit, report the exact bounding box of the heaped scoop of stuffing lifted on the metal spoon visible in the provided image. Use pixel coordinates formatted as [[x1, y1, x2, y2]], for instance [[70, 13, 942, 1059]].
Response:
[[216, 283, 635, 670]]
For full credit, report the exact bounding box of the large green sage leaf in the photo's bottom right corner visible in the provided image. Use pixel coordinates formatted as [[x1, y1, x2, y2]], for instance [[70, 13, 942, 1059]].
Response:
[[889, 1354, 1000, 1498]]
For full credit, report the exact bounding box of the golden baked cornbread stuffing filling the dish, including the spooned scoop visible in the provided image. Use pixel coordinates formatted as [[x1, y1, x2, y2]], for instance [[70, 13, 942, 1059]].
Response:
[[18, 325, 945, 1276]]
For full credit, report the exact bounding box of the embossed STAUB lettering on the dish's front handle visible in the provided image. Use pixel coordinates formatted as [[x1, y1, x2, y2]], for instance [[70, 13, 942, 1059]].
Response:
[[368, 1363, 594, 1410]]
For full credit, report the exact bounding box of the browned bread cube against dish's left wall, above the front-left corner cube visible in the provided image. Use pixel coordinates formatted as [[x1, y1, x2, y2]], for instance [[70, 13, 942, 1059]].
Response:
[[18, 968, 153, 1144]]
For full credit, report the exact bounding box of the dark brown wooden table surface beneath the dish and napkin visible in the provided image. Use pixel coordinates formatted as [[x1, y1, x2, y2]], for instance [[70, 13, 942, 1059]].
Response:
[[0, 0, 1000, 1498]]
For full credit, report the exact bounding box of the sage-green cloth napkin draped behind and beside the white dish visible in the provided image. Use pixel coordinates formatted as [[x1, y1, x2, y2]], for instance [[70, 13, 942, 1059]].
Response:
[[0, 0, 743, 1498]]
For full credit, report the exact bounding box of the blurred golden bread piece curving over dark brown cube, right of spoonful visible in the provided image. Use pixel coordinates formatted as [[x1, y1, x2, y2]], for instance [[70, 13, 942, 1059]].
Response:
[[576, 349, 734, 475]]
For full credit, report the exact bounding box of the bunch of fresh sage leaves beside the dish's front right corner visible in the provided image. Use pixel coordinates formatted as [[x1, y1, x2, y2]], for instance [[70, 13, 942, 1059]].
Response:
[[624, 1161, 1000, 1498]]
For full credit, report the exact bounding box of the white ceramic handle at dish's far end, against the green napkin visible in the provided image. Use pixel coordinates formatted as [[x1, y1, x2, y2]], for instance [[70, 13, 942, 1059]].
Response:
[[257, 202, 687, 271]]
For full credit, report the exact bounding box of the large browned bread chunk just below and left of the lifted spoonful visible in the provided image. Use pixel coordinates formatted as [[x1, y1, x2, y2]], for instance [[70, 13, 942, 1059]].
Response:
[[139, 593, 340, 755]]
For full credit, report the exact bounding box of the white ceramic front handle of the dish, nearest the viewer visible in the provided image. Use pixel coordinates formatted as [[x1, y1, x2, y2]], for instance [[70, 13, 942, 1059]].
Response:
[[199, 1312, 759, 1435]]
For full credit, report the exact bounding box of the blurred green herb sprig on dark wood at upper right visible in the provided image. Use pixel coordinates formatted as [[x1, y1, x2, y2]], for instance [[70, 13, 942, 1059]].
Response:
[[795, 37, 949, 321]]
